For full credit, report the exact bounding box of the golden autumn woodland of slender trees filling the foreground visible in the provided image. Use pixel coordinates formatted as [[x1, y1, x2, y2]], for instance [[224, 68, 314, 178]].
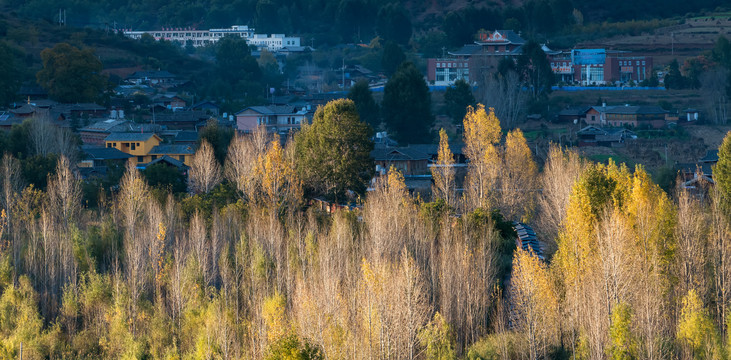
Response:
[[0, 100, 731, 359]]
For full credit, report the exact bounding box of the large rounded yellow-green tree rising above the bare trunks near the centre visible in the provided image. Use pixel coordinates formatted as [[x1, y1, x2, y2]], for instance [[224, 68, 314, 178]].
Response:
[[295, 99, 374, 199]]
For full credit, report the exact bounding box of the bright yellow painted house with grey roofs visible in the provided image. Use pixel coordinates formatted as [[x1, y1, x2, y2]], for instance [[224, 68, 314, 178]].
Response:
[[104, 133, 195, 166]]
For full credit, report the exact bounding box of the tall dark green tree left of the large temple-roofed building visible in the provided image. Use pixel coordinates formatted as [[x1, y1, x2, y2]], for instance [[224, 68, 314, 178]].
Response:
[[381, 62, 434, 144]]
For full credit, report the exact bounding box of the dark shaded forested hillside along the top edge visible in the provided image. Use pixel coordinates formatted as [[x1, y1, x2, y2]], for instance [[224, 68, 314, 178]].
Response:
[[4, 0, 727, 46]]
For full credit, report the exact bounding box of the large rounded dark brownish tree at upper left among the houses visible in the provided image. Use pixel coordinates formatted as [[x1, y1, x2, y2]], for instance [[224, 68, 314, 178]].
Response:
[[36, 43, 107, 103]]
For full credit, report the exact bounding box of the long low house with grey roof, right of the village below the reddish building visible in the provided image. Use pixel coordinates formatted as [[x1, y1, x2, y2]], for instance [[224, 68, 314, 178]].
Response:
[[584, 104, 670, 129]]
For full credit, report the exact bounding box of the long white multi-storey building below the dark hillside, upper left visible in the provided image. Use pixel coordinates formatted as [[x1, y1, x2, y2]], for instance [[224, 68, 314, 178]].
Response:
[[124, 25, 300, 52]]
